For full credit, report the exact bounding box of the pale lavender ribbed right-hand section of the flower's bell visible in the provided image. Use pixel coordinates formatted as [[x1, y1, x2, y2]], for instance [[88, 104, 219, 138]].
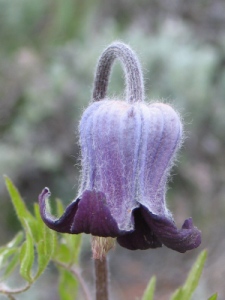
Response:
[[138, 103, 182, 215]]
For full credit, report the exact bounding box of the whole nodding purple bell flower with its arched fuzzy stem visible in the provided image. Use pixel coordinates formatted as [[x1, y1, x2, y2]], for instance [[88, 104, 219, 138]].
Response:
[[39, 42, 201, 252]]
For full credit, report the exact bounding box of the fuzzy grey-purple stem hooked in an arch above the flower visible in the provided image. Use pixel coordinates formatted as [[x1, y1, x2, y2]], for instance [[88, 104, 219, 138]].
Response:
[[93, 42, 144, 103]]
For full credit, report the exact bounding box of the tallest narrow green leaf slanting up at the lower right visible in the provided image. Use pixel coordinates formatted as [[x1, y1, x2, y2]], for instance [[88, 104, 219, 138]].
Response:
[[171, 251, 207, 300]]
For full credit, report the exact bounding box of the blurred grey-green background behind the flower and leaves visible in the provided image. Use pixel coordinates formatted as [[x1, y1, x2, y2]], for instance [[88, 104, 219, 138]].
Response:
[[0, 0, 225, 300]]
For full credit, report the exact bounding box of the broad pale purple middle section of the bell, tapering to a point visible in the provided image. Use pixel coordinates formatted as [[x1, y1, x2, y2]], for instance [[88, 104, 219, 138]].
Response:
[[80, 101, 141, 230]]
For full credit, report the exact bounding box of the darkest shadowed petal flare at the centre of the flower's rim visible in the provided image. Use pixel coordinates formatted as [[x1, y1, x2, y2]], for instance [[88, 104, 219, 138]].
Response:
[[117, 209, 162, 250]]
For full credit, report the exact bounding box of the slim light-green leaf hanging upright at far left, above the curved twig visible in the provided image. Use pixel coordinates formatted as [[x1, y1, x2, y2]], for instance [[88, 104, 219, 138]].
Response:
[[20, 221, 34, 283]]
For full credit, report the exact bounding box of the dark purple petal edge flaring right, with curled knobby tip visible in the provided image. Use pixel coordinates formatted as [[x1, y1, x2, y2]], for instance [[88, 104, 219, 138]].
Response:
[[141, 207, 201, 253]]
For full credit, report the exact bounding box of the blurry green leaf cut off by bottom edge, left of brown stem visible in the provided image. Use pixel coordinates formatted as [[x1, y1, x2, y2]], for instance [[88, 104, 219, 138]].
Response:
[[58, 268, 78, 300]]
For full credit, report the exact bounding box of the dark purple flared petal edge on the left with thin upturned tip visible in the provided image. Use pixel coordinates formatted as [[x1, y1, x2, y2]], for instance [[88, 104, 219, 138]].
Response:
[[39, 188, 122, 237]]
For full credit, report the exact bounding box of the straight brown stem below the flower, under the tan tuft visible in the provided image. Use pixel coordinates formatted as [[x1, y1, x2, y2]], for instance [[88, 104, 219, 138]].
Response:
[[94, 257, 108, 300]]
